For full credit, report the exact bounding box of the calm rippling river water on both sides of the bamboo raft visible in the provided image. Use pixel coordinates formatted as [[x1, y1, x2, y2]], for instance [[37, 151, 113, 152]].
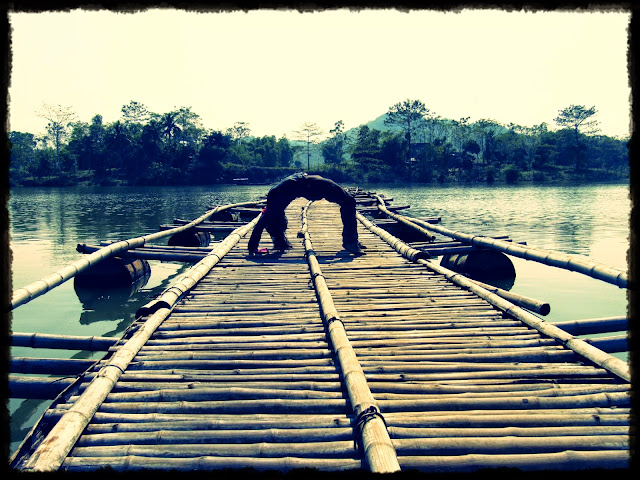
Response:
[[8, 185, 631, 451]]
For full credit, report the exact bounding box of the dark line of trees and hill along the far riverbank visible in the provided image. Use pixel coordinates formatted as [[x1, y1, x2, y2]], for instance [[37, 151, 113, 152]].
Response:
[[9, 99, 629, 186]]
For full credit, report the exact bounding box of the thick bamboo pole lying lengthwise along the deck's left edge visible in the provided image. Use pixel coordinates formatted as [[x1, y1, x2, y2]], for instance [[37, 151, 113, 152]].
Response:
[[25, 215, 258, 471]]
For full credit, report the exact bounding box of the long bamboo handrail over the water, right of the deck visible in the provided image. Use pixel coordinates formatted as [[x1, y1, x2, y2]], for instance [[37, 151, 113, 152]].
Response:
[[375, 195, 628, 288]]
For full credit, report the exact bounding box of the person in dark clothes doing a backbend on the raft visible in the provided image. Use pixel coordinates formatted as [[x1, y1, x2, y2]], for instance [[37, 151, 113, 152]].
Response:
[[249, 173, 365, 255]]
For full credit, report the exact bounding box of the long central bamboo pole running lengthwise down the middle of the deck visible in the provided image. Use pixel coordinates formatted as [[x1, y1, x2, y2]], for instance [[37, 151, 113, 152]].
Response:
[[300, 202, 400, 473]]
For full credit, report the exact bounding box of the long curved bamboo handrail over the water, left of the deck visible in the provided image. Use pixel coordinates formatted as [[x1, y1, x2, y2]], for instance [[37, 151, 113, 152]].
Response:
[[9, 202, 255, 310]]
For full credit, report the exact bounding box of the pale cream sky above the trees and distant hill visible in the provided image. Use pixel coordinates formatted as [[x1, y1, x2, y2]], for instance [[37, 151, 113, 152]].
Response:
[[9, 9, 630, 138]]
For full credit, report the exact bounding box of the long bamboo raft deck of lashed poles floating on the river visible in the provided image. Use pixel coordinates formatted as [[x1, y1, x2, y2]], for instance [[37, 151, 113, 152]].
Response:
[[11, 192, 631, 473]]
